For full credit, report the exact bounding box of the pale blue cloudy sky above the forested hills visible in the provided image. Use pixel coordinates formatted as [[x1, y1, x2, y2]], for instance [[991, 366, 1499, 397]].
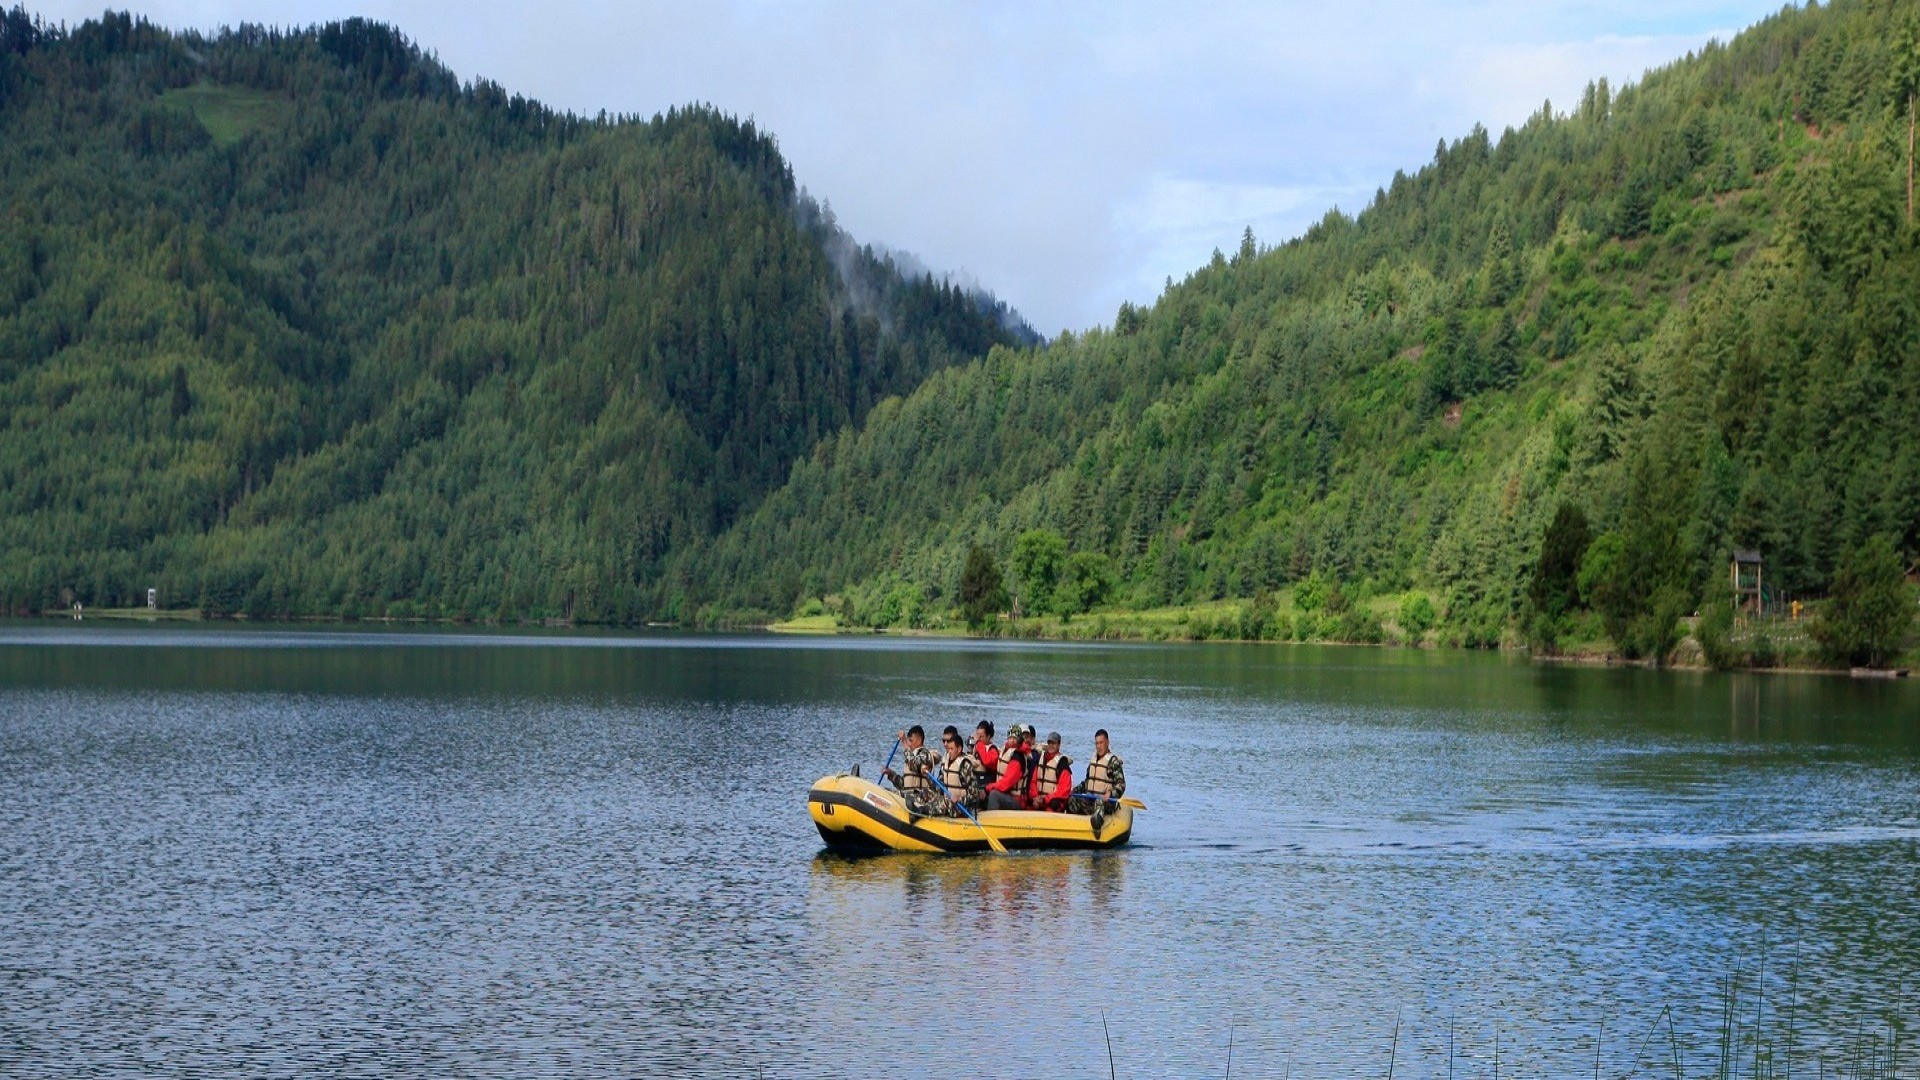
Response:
[[41, 0, 1780, 336]]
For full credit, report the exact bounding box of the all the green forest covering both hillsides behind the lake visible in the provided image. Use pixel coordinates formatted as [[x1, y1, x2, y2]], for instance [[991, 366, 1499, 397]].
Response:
[[0, 0, 1920, 665]]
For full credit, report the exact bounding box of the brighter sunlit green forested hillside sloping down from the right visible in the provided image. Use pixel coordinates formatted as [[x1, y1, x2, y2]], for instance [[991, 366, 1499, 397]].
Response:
[[691, 2, 1920, 655]]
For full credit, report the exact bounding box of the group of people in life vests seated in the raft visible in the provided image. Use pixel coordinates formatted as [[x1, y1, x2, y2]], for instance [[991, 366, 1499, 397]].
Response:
[[881, 721, 1127, 836]]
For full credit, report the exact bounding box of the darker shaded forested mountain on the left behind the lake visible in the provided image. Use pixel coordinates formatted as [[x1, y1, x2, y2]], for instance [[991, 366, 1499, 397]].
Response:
[[0, 8, 1037, 621]]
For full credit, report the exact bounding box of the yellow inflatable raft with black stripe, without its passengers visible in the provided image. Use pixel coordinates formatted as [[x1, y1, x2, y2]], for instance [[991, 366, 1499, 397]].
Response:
[[806, 773, 1133, 851]]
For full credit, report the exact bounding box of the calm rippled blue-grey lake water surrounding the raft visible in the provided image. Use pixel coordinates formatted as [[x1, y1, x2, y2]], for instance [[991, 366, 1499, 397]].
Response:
[[0, 621, 1920, 1076]]
